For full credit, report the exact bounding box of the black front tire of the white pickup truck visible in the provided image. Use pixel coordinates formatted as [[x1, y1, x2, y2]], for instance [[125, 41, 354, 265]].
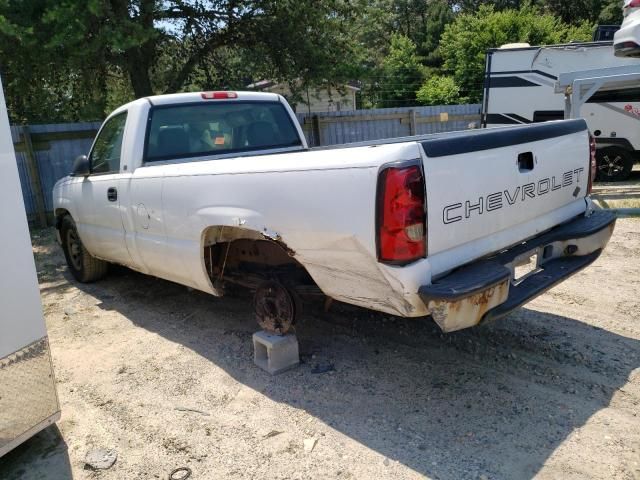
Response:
[[60, 215, 109, 283]]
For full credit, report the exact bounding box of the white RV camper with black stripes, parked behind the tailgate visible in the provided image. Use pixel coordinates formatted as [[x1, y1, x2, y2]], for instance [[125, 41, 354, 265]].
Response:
[[482, 42, 640, 181]]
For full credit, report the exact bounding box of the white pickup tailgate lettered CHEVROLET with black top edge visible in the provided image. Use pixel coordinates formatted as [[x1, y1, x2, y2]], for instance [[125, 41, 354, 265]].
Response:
[[422, 120, 590, 275]]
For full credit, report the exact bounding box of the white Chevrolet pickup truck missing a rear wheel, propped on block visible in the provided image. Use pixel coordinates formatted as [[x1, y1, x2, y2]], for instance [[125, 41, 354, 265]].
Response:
[[53, 92, 615, 333]]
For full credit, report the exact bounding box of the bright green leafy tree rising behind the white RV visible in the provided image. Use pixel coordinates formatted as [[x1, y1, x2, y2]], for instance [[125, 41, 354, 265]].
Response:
[[440, 5, 592, 102]]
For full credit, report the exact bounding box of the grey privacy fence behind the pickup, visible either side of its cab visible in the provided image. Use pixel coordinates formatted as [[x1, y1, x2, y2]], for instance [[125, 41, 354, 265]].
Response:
[[11, 105, 480, 226]]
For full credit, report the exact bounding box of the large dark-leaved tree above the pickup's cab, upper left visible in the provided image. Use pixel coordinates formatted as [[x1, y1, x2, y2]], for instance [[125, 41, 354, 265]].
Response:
[[0, 0, 354, 120]]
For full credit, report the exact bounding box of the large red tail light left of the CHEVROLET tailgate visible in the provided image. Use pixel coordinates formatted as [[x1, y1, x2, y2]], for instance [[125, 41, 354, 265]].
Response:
[[377, 165, 427, 265]]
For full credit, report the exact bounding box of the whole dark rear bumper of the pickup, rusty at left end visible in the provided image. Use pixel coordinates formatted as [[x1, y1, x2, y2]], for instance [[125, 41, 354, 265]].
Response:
[[419, 210, 616, 332]]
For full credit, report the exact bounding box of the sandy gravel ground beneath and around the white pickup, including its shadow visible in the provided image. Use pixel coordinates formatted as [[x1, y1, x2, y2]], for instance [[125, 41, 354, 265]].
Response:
[[0, 218, 640, 480]]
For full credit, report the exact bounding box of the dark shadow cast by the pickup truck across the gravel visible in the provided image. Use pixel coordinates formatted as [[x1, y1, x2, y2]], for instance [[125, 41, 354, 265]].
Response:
[[76, 269, 640, 479]]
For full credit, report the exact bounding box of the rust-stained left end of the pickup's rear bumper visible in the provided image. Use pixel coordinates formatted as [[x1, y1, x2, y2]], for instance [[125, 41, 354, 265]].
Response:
[[428, 280, 509, 333]]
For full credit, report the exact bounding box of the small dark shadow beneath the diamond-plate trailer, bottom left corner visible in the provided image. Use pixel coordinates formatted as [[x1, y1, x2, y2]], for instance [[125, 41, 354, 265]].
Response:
[[0, 425, 73, 480]]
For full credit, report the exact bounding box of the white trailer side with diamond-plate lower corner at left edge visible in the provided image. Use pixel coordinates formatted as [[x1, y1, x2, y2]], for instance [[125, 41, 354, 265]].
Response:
[[0, 77, 60, 457]]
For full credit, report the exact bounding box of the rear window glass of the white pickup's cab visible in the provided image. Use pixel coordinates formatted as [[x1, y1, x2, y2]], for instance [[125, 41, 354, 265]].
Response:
[[145, 100, 302, 162]]
